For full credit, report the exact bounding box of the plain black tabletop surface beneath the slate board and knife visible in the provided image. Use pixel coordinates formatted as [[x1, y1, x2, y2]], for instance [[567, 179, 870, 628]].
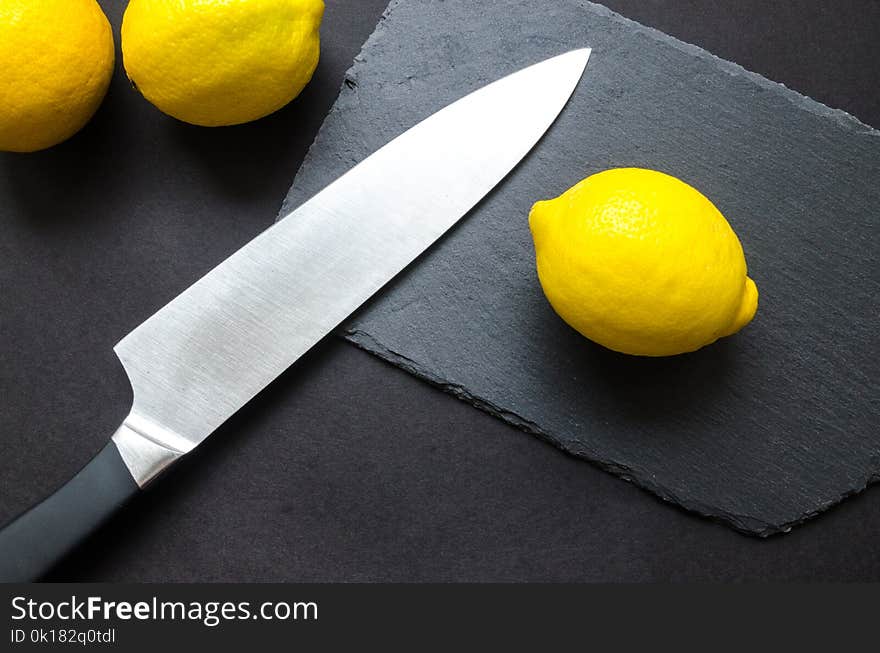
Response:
[[0, 0, 880, 581]]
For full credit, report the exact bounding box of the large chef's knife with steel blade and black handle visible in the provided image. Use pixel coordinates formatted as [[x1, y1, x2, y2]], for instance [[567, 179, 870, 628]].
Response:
[[0, 49, 590, 582]]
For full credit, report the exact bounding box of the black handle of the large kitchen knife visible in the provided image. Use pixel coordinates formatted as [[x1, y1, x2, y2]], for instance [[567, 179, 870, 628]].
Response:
[[0, 440, 139, 583]]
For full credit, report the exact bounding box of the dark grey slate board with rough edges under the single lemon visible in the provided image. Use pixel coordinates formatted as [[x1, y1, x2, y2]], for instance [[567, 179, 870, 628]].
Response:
[[281, 0, 880, 536]]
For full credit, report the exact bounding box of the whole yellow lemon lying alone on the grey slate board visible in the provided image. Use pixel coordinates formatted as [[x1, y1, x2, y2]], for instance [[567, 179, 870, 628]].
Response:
[[529, 168, 758, 356]]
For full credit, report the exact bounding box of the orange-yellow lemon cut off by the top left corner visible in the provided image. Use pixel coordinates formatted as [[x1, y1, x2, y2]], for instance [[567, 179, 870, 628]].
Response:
[[0, 0, 115, 152]]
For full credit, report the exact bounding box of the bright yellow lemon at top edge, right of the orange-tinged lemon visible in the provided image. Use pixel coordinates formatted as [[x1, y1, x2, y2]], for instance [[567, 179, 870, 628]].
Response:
[[122, 0, 324, 127]]
